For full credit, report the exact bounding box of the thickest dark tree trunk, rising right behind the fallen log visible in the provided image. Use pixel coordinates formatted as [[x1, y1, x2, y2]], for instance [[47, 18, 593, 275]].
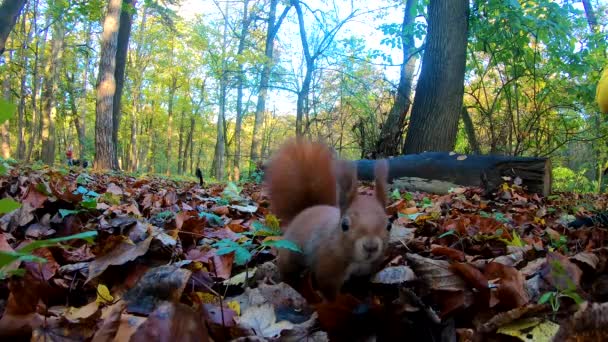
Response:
[[403, 0, 469, 153]]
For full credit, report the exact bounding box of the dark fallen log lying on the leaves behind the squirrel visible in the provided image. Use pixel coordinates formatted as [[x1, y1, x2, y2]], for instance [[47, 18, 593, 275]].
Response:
[[356, 152, 551, 196]]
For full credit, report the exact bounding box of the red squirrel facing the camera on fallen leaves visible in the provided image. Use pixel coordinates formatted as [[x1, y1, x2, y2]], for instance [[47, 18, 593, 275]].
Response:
[[266, 139, 390, 301]]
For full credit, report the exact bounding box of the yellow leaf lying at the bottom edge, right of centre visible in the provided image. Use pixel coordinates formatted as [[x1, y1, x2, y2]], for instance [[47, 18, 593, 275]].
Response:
[[497, 318, 559, 342]]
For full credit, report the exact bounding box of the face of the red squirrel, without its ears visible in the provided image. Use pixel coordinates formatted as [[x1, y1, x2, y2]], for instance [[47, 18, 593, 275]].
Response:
[[340, 196, 389, 262]]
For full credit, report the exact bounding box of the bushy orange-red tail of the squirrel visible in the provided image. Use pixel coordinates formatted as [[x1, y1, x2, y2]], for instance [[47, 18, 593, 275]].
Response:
[[265, 139, 338, 226]]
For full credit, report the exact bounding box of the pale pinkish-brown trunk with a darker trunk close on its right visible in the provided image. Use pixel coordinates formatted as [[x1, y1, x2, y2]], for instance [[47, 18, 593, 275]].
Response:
[[94, 0, 122, 170]]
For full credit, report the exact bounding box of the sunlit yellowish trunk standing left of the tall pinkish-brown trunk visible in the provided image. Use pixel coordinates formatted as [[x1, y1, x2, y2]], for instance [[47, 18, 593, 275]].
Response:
[[42, 21, 65, 165]]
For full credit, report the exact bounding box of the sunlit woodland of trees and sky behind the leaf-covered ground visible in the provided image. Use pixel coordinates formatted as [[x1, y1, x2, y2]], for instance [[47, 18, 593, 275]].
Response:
[[0, 0, 608, 192]]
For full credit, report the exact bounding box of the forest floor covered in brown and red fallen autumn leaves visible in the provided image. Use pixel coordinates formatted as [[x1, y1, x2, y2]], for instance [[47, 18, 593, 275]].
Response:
[[0, 165, 608, 342]]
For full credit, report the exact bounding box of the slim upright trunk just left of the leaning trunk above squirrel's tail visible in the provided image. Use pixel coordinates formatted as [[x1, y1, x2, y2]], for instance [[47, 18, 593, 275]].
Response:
[[234, 0, 250, 181]]
